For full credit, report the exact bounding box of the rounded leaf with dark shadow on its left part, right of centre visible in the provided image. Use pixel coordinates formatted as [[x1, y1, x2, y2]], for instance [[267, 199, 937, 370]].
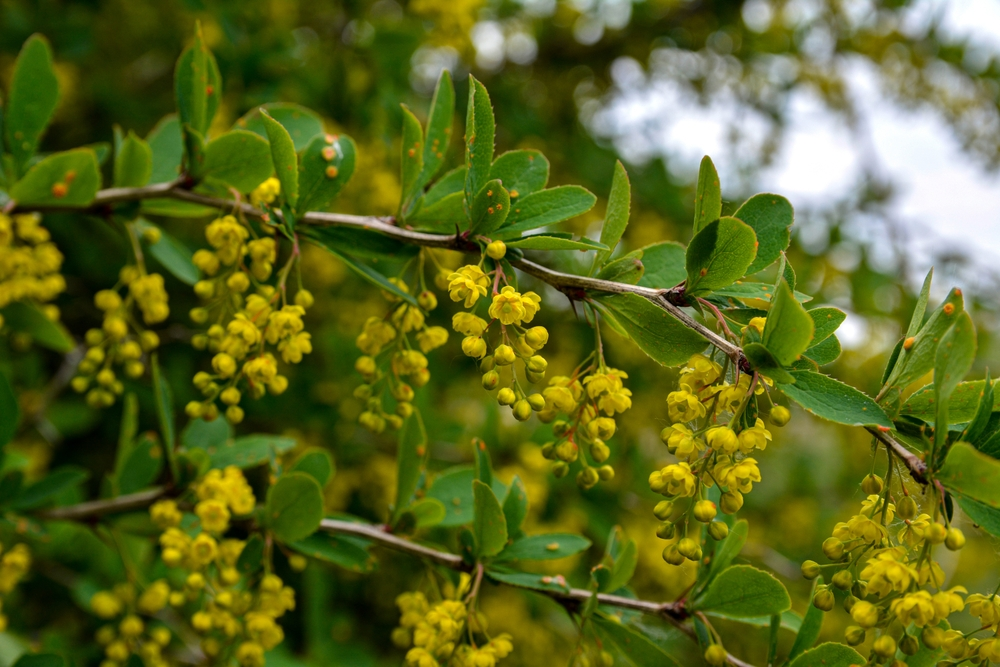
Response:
[[684, 218, 757, 297]]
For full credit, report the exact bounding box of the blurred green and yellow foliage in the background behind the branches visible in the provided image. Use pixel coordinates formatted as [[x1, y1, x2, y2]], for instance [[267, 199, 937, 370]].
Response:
[[0, 0, 1000, 666]]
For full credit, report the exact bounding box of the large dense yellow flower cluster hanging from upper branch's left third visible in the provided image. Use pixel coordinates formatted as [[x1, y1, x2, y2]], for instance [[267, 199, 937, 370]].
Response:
[[185, 213, 313, 424]]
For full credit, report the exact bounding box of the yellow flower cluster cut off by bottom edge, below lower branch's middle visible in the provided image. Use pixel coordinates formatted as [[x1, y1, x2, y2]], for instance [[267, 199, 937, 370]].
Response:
[[392, 574, 514, 667]]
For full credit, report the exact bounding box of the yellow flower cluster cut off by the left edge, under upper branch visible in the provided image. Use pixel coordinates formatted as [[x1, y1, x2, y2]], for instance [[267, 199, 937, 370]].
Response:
[[0, 213, 66, 328]]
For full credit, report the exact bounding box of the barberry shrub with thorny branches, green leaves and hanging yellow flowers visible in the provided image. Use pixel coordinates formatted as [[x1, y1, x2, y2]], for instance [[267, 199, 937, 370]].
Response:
[[0, 23, 1000, 667]]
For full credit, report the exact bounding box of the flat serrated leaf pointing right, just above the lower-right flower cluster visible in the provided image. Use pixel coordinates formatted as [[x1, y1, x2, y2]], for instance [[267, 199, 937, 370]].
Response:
[[780, 371, 892, 428]]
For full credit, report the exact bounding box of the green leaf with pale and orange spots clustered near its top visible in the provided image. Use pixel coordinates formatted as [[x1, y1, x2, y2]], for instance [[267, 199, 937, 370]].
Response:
[[296, 134, 356, 215]]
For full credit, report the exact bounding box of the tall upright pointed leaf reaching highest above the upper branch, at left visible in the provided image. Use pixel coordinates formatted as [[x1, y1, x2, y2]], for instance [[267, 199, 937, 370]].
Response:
[[174, 24, 222, 136]]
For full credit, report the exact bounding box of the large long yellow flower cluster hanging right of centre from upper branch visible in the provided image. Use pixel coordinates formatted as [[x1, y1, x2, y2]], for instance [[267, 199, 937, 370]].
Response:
[[649, 354, 776, 565]]
